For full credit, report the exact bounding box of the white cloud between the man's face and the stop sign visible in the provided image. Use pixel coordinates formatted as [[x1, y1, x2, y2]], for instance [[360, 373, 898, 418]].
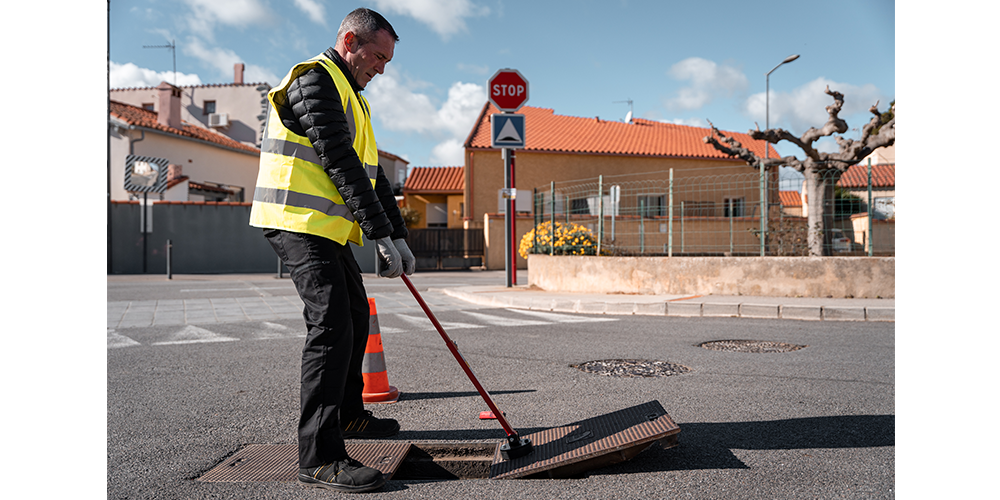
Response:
[[365, 66, 487, 165]]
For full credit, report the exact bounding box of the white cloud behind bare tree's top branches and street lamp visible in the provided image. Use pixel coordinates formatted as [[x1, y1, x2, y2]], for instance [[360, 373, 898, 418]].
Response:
[[743, 77, 889, 137]]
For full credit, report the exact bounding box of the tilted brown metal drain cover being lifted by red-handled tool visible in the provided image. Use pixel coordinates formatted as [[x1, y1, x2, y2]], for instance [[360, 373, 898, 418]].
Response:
[[490, 401, 681, 479]]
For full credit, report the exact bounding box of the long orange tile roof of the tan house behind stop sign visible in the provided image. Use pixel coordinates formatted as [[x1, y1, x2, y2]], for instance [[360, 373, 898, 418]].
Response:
[[465, 103, 779, 159]]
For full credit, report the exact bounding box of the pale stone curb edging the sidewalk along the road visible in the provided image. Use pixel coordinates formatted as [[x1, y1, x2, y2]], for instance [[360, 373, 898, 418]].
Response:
[[442, 288, 896, 322]]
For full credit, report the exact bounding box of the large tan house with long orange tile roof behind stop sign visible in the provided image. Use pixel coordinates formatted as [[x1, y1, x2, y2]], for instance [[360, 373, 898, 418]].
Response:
[[463, 103, 778, 269]]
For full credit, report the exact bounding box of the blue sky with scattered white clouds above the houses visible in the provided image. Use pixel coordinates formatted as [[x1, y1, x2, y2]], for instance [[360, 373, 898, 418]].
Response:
[[109, 0, 896, 176]]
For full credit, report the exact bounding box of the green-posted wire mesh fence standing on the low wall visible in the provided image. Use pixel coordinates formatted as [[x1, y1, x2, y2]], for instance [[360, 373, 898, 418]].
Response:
[[528, 169, 895, 256]]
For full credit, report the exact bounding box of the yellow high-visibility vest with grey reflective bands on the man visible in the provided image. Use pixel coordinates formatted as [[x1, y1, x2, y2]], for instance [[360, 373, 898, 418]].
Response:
[[250, 55, 378, 245]]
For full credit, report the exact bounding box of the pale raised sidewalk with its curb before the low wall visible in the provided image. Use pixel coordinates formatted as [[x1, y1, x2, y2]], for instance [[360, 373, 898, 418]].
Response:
[[431, 285, 896, 321]]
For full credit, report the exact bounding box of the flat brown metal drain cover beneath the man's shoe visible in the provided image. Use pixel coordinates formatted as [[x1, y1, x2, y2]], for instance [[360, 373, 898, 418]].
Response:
[[198, 442, 410, 483]]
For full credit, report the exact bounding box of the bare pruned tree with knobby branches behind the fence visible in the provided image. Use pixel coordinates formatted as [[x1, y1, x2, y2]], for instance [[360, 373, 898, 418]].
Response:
[[703, 86, 896, 256]]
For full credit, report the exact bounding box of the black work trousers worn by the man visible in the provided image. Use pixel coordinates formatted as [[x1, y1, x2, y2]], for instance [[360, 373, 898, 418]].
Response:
[[264, 229, 369, 468]]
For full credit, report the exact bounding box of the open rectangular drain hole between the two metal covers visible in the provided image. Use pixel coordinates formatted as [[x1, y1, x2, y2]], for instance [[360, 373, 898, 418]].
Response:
[[392, 443, 500, 480]]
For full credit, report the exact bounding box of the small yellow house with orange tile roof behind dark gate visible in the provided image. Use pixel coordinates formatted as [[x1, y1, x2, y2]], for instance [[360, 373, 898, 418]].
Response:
[[403, 167, 465, 229]]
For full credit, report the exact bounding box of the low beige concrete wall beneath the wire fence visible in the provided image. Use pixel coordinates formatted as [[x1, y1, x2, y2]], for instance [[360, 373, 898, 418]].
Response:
[[528, 254, 896, 298]]
